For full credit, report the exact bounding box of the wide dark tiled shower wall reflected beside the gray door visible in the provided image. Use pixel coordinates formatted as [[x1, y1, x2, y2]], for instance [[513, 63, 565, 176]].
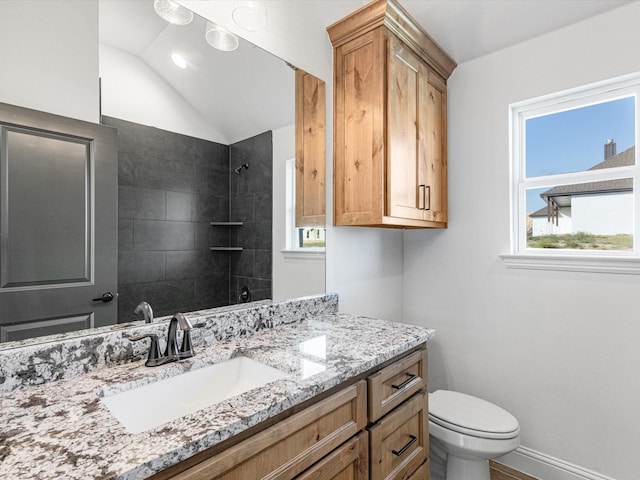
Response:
[[103, 117, 234, 322]]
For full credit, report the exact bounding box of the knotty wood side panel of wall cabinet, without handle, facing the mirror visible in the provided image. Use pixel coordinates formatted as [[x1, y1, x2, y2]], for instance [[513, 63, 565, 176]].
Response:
[[333, 27, 385, 225]]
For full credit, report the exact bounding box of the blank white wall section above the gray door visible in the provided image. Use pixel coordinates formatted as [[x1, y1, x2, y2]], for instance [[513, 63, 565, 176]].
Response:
[[0, 0, 99, 122]]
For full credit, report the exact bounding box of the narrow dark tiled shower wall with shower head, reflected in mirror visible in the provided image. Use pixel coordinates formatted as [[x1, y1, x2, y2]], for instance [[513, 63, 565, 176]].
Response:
[[229, 131, 273, 304]]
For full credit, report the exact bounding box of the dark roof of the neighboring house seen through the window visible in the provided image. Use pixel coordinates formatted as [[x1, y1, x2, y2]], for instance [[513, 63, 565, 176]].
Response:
[[534, 146, 636, 204]]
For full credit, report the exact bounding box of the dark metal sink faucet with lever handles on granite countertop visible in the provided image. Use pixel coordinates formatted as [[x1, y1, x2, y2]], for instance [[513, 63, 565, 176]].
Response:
[[129, 312, 196, 367]]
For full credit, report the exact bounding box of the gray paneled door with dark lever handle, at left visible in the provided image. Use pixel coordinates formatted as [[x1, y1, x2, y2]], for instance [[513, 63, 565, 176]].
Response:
[[0, 103, 118, 342]]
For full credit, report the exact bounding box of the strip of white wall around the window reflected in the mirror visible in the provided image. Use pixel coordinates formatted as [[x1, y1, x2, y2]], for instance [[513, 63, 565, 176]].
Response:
[[273, 125, 325, 300]]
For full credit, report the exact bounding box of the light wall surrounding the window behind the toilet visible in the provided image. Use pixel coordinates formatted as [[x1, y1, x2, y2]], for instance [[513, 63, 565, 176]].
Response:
[[404, 2, 640, 480]]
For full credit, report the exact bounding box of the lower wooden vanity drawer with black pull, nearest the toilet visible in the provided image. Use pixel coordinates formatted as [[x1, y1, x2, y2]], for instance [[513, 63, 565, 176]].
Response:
[[369, 393, 429, 480]]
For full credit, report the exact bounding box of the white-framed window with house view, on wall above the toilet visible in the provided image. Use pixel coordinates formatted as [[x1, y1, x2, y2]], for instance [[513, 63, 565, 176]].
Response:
[[503, 75, 640, 273]]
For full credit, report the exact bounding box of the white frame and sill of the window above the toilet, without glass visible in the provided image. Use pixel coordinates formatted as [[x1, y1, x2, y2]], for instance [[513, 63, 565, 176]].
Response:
[[500, 73, 640, 274]]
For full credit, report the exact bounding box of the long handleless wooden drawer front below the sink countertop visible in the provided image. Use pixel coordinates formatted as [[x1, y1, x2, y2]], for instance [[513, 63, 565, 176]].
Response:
[[173, 381, 367, 480]]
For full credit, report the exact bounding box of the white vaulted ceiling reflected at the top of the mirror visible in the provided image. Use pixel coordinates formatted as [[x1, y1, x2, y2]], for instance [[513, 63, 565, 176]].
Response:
[[99, 0, 295, 144]]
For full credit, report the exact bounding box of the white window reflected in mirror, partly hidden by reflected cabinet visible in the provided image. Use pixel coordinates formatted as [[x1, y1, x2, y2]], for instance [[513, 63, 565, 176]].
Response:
[[286, 159, 326, 253]]
